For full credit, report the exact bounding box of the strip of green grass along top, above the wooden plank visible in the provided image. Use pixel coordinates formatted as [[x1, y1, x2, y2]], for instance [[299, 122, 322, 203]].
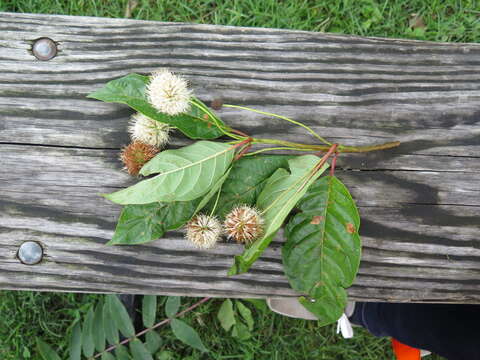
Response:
[[0, 0, 480, 42]]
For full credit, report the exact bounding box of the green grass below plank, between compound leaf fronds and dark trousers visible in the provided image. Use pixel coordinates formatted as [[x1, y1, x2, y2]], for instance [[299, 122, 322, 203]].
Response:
[[153, 299, 393, 360]]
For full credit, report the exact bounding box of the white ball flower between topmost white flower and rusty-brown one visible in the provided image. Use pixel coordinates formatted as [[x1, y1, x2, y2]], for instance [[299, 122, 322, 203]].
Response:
[[128, 113, 171, 148]]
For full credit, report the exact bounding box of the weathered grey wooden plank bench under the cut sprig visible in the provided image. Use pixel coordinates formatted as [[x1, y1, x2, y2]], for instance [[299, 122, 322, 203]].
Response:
[[0, 13, 480, 303]]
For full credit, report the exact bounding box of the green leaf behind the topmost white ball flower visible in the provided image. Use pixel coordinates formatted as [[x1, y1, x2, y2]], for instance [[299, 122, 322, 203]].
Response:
[[87, 74, 225, 139]]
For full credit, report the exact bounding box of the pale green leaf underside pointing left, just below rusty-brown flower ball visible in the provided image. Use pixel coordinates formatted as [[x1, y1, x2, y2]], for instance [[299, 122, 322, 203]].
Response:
[[105, 141, 235, 205]]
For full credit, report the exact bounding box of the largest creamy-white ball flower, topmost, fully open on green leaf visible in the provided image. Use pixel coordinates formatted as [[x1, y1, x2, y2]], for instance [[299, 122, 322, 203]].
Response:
[[147, 69, 192, 115]]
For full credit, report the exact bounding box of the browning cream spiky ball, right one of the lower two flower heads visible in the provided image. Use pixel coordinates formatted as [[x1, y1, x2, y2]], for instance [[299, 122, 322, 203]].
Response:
[[223, 205, 263, 245]]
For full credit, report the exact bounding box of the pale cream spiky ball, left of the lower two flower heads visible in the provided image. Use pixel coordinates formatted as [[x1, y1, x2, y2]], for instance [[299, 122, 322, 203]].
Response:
[[186, 214, 222, 249]]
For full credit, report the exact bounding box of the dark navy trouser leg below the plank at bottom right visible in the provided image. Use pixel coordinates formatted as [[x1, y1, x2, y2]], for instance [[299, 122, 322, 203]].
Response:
[[350, 302, 480, 360]]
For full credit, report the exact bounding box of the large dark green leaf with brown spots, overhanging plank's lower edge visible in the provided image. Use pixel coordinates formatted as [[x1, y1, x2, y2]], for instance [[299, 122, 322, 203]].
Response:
[[282, 176, 361, 325]]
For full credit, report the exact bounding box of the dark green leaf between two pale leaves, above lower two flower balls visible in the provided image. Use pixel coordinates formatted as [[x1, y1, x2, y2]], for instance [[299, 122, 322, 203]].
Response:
[[207, 155, 292, 217]]
